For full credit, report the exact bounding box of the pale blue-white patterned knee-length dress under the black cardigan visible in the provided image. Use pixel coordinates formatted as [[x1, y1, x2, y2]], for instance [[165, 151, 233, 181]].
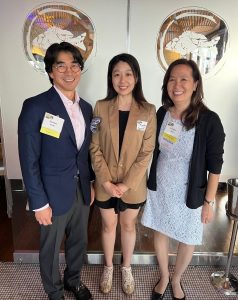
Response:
[[141, 112, 203, 245]]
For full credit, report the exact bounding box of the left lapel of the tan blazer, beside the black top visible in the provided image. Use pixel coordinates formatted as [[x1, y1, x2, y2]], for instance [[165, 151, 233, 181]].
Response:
[[108, 99, 119, 162]]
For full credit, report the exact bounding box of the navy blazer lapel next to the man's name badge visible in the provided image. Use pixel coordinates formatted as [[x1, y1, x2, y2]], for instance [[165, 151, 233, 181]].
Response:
[[46, 87, 77, 147]]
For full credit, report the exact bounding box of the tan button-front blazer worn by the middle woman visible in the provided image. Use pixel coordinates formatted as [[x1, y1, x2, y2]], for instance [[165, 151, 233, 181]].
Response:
[[90, 99, 156, 203]]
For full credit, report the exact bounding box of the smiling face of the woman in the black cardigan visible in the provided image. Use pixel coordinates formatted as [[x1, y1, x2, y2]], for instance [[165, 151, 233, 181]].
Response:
[[167, 65, 197, 105]]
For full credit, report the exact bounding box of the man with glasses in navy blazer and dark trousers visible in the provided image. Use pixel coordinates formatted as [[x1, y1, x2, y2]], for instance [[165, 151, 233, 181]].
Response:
[[18, 42, 94, 300]]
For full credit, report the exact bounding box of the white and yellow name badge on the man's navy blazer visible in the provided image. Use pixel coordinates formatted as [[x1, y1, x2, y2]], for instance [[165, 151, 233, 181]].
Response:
[[40, 112, 64, 138]]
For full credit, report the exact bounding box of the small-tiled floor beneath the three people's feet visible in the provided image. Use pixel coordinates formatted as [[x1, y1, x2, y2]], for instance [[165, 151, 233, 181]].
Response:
[[0, 262, 238, 300]]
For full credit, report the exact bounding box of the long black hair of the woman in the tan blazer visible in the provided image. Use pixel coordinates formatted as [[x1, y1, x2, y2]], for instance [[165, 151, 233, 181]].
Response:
[[105, 53, 147, 105]]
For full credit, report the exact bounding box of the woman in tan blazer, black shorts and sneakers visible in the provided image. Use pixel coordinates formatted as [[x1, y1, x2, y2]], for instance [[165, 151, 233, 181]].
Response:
[[90, 53, 156, 294]]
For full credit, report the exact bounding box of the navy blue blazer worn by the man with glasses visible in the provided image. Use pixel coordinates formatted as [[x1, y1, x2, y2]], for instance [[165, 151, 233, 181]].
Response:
[[18, 87, 94, 216]]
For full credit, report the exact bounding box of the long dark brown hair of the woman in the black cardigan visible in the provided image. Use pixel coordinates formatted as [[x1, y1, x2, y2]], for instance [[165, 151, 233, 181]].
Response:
[[162, 58, 208, 130]]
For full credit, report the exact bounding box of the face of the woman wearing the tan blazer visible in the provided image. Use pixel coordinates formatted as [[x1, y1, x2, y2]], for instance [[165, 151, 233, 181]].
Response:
[[112, 61, 136, 96]]
